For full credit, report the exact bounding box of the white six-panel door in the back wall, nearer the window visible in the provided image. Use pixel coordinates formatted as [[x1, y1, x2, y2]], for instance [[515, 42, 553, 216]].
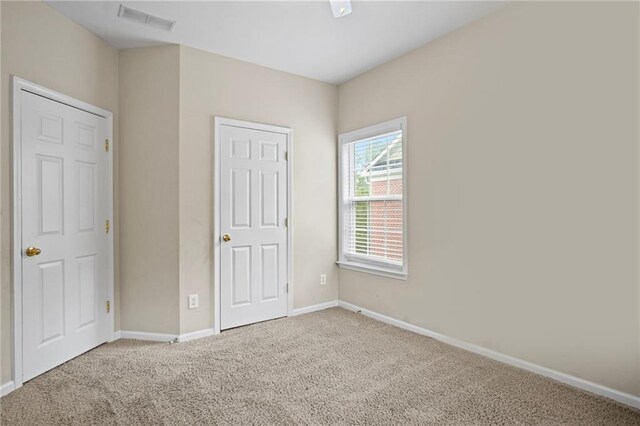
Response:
[[219, 125, 288, 330]]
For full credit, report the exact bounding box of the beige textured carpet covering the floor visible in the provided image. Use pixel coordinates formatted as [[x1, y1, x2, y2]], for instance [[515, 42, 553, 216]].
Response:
[[0, 308, 640, 425]]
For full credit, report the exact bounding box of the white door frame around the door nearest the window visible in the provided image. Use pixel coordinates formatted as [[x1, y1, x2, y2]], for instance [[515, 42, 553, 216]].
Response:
[[213, 117, 293, 334]]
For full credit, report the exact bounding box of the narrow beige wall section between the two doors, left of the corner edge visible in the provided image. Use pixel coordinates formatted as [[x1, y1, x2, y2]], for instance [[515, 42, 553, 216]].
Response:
[[119, 46, 180, 334]]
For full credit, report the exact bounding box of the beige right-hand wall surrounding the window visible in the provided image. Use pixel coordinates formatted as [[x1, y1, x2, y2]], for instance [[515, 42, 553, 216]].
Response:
[[339, 2, 640, 395]]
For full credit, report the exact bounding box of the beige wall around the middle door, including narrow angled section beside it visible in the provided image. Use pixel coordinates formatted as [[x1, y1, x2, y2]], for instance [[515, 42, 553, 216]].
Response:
[[119, 46, 338, 334]]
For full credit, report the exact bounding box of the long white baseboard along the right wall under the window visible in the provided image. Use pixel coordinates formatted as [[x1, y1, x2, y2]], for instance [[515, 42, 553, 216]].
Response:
[[338, 300, 640, 408]]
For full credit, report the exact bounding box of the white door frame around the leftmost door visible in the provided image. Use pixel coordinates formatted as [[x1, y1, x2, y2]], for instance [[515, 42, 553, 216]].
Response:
[[10, 76, 115, 389]]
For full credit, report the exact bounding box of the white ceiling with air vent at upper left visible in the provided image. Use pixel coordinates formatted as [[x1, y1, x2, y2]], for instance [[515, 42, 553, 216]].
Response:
[[47, 1, 504, 84]]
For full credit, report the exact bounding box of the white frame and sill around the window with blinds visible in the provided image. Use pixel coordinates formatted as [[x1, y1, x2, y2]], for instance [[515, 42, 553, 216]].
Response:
[[336, 117, 409, 280]]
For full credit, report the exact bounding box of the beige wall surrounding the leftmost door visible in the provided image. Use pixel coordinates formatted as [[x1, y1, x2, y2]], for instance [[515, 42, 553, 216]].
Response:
[[0, 1, 118, 383]]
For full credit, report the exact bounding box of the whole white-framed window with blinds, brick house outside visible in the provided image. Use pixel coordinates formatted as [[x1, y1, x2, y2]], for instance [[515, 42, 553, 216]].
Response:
[[338, 118, 407, 279]]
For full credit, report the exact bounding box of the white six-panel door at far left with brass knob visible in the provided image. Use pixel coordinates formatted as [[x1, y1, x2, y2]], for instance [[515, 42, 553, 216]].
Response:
[[16, 91, 108, 381]]
